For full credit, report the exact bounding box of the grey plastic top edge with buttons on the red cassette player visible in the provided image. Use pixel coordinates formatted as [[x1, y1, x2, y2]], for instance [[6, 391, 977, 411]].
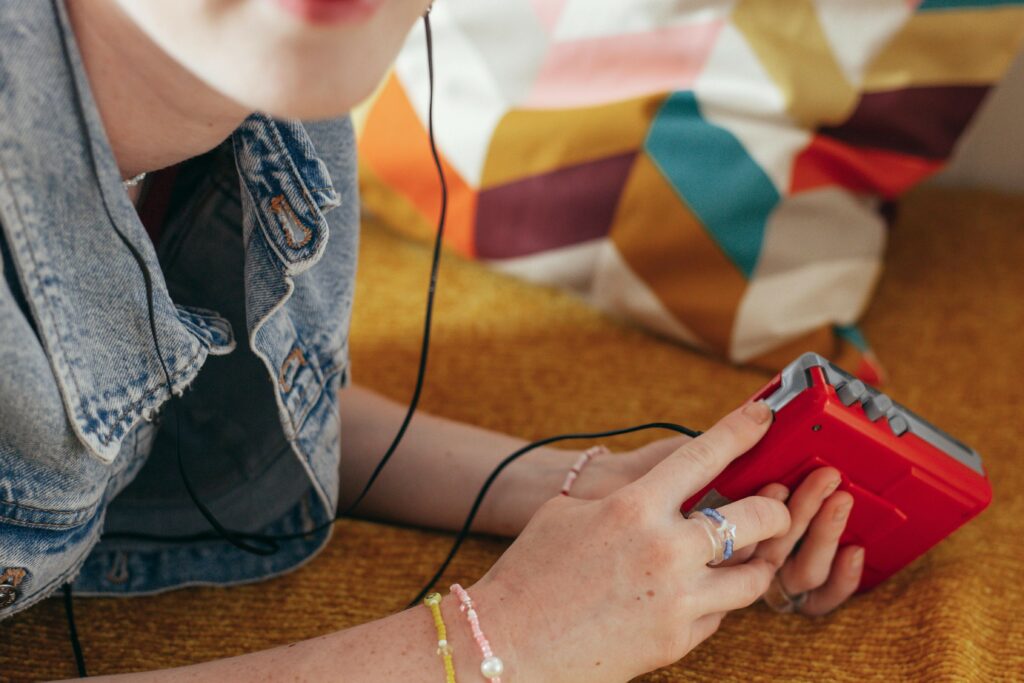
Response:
[[765, 353, 985, 476]]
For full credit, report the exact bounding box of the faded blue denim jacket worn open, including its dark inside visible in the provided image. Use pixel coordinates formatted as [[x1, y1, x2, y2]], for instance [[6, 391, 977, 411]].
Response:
[[0, 0, 358, 617]]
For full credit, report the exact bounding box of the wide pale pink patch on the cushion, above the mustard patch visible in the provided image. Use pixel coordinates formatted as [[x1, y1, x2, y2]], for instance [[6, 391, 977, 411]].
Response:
[[524, 19, 725, 109]]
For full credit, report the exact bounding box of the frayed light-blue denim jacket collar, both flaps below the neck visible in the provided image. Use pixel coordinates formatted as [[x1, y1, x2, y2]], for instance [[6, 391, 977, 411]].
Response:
[[0, 0, 340, 462]]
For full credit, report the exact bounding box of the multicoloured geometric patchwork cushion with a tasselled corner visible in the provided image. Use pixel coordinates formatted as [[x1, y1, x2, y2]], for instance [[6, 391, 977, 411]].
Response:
[[359, 0, 1024, 383]]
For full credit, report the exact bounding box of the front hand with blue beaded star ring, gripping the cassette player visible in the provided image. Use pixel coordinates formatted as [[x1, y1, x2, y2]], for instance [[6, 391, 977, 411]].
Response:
[[471, 403, 790, 683]]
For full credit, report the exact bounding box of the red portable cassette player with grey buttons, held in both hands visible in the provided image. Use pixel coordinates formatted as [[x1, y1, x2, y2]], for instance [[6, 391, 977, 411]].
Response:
[[683, 353, 992, 592]]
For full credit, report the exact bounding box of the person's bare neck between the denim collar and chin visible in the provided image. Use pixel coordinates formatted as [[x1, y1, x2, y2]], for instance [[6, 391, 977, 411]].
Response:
[[68, 0, 249, 178]]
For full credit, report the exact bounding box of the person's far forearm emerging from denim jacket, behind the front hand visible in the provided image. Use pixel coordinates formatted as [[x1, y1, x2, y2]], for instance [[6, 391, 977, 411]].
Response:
[[340, 386, 574, 536]]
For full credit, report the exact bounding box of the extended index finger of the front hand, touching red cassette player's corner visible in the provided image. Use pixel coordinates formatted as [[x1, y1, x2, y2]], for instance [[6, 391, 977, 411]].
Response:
[[636, 400, 772, 508]]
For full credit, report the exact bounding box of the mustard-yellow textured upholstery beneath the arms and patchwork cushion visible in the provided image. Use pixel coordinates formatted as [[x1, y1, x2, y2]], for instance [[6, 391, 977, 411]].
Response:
[[0, 190, 1024, 683]]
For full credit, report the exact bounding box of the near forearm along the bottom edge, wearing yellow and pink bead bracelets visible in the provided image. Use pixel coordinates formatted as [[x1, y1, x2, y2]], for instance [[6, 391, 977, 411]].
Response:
[[74, 587, 514, 683]]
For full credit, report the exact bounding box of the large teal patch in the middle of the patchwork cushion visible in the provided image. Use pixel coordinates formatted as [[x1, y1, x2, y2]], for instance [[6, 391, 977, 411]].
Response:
[[644, 91, 779, 280]]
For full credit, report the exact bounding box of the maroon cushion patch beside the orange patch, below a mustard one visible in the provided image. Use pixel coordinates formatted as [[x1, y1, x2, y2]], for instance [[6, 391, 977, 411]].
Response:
[[476, 152, 637, 259]]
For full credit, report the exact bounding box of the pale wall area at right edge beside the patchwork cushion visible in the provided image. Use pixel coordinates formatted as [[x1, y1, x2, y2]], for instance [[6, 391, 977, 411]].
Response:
[[933, 52, 1024, 194]]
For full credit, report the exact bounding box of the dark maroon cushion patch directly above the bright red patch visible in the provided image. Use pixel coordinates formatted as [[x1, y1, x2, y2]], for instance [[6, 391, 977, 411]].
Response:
[[819, 85, 989, 159]]
